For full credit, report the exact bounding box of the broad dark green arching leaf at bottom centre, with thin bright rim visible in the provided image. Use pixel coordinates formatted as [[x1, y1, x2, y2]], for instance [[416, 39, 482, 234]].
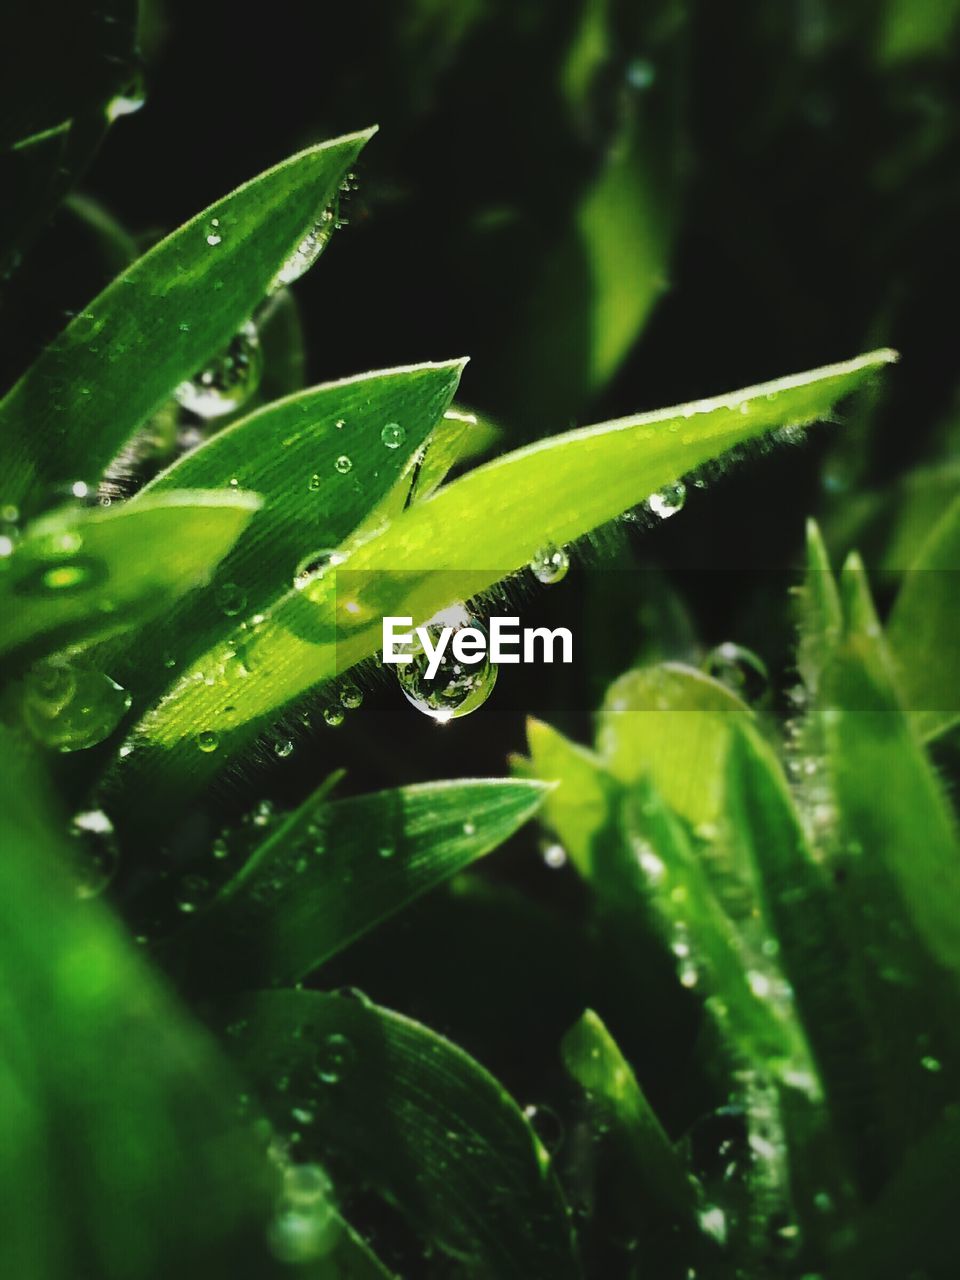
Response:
[[229, 991, 580, 1280]]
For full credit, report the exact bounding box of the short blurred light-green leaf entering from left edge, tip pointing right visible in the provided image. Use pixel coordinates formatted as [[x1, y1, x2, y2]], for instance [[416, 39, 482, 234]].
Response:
[[0, 490, 260, 658]]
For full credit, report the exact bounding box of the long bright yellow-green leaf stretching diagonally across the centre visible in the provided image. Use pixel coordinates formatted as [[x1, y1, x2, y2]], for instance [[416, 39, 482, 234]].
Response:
[[116, 351, 895, 808]]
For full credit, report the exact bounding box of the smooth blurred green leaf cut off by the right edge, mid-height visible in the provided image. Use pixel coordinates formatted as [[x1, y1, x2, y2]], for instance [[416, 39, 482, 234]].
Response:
[[887, 498, 960, 741]]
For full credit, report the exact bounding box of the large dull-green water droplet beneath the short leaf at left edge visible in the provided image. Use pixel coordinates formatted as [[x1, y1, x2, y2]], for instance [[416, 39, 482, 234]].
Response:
[[23, 660, 133, 751]]
